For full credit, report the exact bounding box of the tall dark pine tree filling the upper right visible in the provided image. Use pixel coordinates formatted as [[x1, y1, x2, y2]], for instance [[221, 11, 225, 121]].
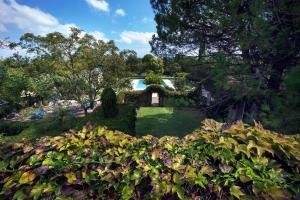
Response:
[[151, 0, 300, 125]]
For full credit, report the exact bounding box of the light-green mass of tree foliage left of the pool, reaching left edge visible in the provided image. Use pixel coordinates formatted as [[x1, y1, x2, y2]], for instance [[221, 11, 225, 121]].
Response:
[[0, 28, 130, 115]]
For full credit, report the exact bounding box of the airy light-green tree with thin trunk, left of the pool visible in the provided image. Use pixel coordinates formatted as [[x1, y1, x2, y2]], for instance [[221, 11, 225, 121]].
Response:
[[20, 28, 129, 113]]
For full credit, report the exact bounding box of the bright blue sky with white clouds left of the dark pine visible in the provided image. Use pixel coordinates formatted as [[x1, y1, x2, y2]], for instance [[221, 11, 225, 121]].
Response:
[[0, 0, 156, 57]]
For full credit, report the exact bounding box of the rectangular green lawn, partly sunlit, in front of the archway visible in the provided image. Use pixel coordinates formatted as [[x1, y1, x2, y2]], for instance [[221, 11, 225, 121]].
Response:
[[136, 107, 204, 137]]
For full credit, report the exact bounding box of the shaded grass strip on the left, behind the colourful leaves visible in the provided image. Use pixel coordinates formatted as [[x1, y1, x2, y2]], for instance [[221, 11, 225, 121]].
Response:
[[0, 105, 135, 142]]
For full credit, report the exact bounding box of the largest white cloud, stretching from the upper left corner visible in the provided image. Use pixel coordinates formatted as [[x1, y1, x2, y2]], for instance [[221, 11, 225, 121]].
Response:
[[0, 0, 75, 34]]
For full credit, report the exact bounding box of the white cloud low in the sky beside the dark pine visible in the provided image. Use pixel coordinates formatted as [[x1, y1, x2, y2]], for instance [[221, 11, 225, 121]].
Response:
[[120, 31, 155, 44]]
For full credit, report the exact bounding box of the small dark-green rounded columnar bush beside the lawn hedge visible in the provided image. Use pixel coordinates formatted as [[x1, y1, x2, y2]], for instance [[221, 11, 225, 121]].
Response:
[[101, 88, 118, 118]]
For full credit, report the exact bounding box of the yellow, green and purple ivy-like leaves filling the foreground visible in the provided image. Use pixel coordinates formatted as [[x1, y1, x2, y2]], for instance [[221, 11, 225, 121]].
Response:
[[0, 120, 300, 199]]
